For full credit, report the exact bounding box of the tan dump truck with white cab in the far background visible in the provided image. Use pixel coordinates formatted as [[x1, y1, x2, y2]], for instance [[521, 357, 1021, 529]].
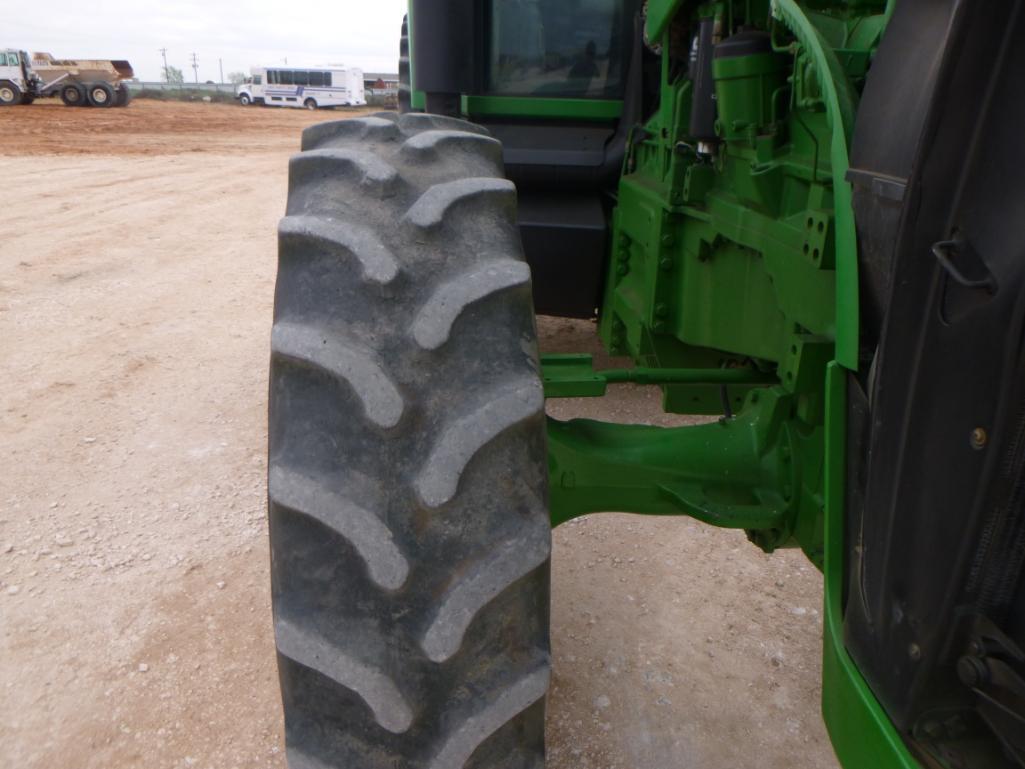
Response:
[[0, 48, 134, 107]]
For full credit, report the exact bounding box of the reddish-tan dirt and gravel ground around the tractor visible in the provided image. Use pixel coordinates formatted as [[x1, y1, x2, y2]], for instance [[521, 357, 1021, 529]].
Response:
[[0, 100, 836, 769]]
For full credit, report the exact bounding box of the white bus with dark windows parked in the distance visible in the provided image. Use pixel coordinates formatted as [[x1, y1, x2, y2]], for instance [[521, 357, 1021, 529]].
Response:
[[235, 67, 367, 110]]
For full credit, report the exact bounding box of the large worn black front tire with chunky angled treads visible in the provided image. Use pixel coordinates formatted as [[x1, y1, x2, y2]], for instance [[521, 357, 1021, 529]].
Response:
[[269, 113, 550, 769]]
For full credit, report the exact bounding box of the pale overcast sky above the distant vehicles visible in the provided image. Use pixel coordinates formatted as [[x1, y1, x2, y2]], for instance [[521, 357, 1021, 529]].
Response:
[[0, 0, 406, 82]]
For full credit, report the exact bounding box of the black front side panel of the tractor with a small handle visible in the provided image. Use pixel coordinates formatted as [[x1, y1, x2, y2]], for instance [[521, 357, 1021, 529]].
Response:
[[845, 0, 1025, 768]]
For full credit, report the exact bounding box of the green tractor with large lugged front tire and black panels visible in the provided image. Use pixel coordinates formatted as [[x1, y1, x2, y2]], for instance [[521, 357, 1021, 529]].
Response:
[[270, 0, 1025, 769]]
